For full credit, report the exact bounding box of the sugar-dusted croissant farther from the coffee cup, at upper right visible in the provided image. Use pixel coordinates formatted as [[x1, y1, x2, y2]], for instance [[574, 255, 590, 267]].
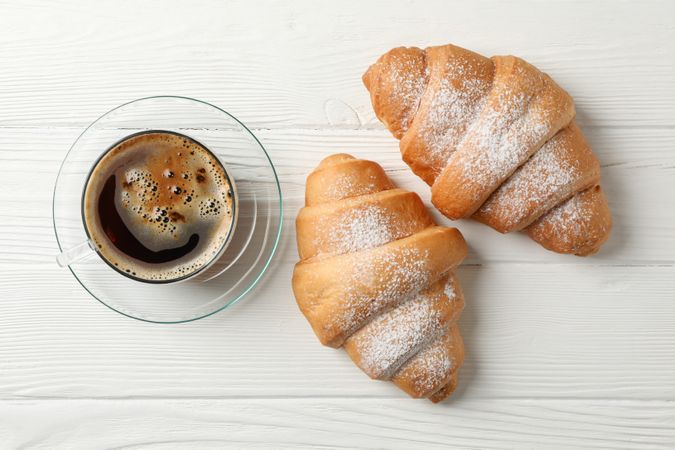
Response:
[[363, 45, 612, 256]]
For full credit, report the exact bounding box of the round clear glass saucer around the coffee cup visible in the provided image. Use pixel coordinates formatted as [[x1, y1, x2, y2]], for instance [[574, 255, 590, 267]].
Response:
[[53, 96, 282, 323]]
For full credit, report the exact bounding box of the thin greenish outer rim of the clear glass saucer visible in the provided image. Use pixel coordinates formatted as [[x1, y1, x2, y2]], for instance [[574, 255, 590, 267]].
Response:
[[52, 95, 284, 324]]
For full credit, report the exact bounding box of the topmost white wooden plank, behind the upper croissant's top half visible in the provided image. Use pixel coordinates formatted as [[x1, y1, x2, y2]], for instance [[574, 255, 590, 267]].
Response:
[[0, 0, 675, 128]]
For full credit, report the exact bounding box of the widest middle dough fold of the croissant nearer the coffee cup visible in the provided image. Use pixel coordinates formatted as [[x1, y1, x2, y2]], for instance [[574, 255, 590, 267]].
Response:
[[293, 226, 466, 347]]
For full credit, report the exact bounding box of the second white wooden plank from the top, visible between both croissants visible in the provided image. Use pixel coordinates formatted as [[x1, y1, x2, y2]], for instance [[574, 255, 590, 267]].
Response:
[[0, 128, 675, 265]]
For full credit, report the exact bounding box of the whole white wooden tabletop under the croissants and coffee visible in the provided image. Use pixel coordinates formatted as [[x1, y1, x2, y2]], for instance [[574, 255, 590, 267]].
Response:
[[0, 0, 675, 449]]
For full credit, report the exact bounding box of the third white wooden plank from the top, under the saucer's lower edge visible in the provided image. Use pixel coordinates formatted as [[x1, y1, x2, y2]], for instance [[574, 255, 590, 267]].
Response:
[[0, 261, 675, 401]]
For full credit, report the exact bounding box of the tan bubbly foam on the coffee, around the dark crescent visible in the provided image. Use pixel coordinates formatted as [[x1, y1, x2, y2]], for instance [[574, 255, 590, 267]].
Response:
[[84, 132, 234, 281]]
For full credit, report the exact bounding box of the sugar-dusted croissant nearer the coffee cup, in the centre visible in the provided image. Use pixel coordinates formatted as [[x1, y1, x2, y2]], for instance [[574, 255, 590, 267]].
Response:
[[293, 154, 467, 402]]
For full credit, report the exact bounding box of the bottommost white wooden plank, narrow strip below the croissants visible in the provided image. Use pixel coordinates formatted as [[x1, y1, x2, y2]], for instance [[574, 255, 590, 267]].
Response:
[[0, 398, 675, 449]]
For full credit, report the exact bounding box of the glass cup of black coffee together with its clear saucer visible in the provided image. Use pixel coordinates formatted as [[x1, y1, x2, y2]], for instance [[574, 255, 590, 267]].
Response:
[[52, 96, 283, 323]]
